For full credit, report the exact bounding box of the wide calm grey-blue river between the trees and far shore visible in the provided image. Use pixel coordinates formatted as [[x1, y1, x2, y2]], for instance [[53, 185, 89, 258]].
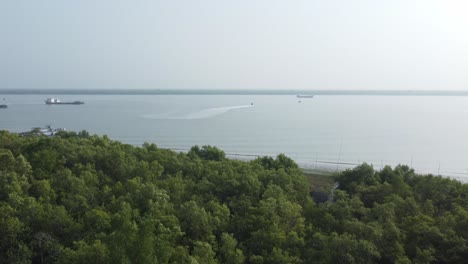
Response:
[[0, 95, 468, 181]]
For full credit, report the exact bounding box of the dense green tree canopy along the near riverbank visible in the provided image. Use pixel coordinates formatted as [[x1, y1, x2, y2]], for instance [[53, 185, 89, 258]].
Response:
[[0, 131, 468, 264]]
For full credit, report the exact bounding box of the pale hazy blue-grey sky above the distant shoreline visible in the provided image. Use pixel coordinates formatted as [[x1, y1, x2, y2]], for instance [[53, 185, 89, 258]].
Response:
[[0, 0, 468, 90]]
